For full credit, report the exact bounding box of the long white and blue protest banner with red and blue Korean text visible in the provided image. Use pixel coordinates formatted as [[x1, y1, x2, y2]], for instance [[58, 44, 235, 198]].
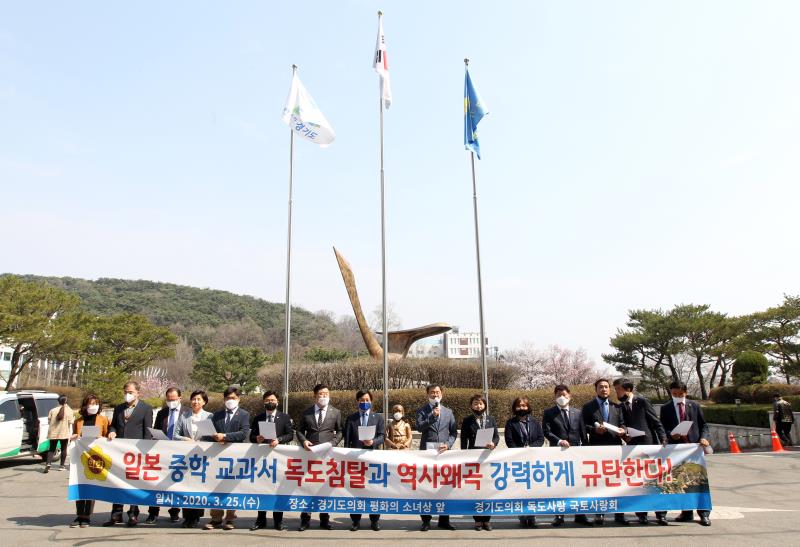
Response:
[[68, 439, 711, 515]]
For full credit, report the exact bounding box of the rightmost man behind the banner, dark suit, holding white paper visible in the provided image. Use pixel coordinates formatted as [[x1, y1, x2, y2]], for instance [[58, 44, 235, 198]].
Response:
[[656, 381, 711, 526]]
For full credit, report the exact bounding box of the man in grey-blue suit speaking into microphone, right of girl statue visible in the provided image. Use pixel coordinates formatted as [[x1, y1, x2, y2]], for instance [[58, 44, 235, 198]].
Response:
[[417, 384, 458, 532]]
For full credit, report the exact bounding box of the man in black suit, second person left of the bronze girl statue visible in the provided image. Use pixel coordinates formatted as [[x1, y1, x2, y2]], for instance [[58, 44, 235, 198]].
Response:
[[297, 384, 342, 532]]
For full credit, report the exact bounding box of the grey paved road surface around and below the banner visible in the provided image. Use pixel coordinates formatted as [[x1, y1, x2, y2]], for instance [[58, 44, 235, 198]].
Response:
[[0, 452, 800, 547]]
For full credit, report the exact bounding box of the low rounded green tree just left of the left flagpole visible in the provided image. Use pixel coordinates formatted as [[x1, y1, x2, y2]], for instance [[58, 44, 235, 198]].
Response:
[[192, 347, 270, 393]]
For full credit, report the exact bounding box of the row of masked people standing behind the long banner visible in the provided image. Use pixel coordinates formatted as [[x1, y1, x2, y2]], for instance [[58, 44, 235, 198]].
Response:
[[54, 378, 710, 531]]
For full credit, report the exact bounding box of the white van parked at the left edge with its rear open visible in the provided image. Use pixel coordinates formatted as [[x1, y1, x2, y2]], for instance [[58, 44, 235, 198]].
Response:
[[0, 390, 59, 459]]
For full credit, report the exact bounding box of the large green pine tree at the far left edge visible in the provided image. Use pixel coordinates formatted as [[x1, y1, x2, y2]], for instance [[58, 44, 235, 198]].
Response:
[[0, 275, 82, 386]]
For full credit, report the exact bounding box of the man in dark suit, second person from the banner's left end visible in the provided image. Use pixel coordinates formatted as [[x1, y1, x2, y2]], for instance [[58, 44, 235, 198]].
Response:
[[103, 381, 153, 526]]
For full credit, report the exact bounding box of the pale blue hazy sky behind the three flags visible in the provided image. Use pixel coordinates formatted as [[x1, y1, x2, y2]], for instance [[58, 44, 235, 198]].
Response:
[[0, 0, 800, 363]]
